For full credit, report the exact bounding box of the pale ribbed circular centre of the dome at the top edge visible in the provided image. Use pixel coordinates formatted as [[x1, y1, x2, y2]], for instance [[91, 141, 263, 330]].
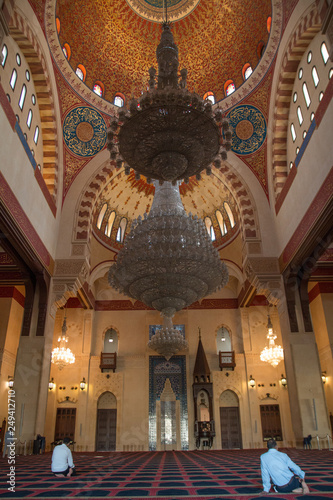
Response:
[[126, 0, 200, 23]]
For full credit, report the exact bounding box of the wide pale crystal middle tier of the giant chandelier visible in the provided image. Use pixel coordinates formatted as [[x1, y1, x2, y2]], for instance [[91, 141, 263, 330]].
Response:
[[109, 182, 228, 318]]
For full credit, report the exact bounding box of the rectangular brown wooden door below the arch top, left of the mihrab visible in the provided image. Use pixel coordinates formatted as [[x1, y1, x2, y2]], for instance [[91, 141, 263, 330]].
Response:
[[96, 409, 117, 451]]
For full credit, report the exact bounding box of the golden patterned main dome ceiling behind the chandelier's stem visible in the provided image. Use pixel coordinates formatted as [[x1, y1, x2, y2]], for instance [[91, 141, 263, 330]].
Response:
[[54, 0, 272, 102]]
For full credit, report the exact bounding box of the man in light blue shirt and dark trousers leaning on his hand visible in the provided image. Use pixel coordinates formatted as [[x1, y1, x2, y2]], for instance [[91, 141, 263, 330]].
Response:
[[260, 439, 309, 495]]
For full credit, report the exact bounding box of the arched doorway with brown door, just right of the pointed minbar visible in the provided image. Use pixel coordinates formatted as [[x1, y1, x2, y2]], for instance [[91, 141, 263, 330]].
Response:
[[220, 390, 242, 450]]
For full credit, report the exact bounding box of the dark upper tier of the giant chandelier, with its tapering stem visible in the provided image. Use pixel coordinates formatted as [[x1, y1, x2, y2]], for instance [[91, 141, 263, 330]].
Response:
[[108, 22, 232, 183]]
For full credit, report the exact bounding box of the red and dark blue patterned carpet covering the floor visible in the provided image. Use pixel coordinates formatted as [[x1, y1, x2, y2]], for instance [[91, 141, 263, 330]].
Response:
[[0, 449, 333, 500]]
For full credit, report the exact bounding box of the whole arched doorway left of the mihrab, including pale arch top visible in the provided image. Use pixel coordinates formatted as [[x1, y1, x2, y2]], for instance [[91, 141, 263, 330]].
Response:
[[96, 392, 117, 451]]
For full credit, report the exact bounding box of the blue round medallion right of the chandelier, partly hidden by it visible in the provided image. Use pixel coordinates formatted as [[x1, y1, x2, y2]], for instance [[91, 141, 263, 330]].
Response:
[[227, 105, 267, 155]]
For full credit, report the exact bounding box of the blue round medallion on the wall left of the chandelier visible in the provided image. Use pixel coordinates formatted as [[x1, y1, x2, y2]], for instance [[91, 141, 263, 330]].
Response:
[[63, 107, 106, 156]]
